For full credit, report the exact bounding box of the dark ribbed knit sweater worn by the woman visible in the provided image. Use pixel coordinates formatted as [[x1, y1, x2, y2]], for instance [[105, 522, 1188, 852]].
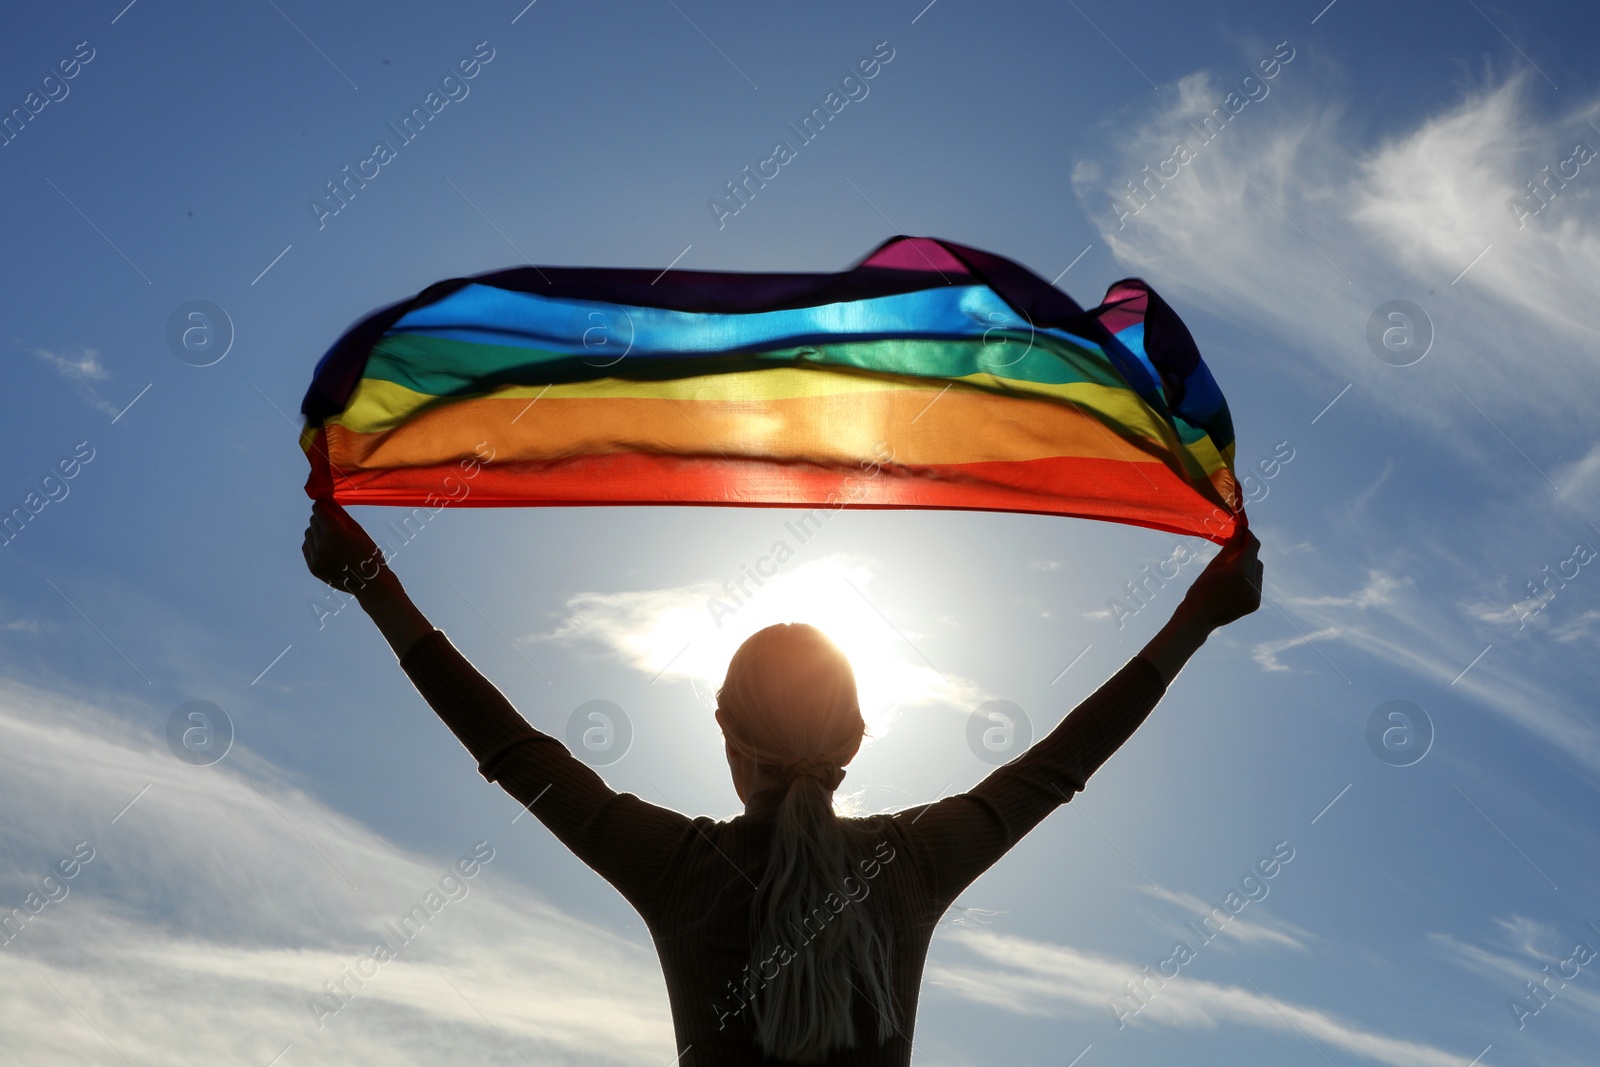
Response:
[[400, 630, 1165, 1067]]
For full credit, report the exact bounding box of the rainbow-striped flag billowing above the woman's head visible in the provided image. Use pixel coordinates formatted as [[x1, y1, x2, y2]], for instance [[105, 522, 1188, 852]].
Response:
[[301, 237, 1245, 542]]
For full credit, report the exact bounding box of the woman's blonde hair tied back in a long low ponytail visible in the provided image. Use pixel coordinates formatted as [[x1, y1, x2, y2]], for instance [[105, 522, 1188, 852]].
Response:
[[717, 622, 896, 1064]]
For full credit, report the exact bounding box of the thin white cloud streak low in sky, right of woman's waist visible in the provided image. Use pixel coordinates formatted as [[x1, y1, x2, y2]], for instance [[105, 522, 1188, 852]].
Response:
[[928, 928, 1464, 1067]]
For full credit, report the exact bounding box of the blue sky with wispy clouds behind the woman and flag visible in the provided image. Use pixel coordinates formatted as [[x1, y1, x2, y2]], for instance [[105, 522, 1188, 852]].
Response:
[[0, 0, 1600, 1067]]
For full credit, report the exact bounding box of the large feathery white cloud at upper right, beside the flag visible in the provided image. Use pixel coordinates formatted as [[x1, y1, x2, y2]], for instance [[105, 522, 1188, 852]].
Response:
[[1074, 66, 1600, 451]]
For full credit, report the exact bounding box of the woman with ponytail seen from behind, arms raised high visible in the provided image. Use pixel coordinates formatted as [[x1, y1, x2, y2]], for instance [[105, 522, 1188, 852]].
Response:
[[302, 501, 1262, 1067]]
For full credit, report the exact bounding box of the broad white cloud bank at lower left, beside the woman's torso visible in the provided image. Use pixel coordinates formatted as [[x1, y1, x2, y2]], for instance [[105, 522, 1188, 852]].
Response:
[[0, 685, 674, 1067]]
